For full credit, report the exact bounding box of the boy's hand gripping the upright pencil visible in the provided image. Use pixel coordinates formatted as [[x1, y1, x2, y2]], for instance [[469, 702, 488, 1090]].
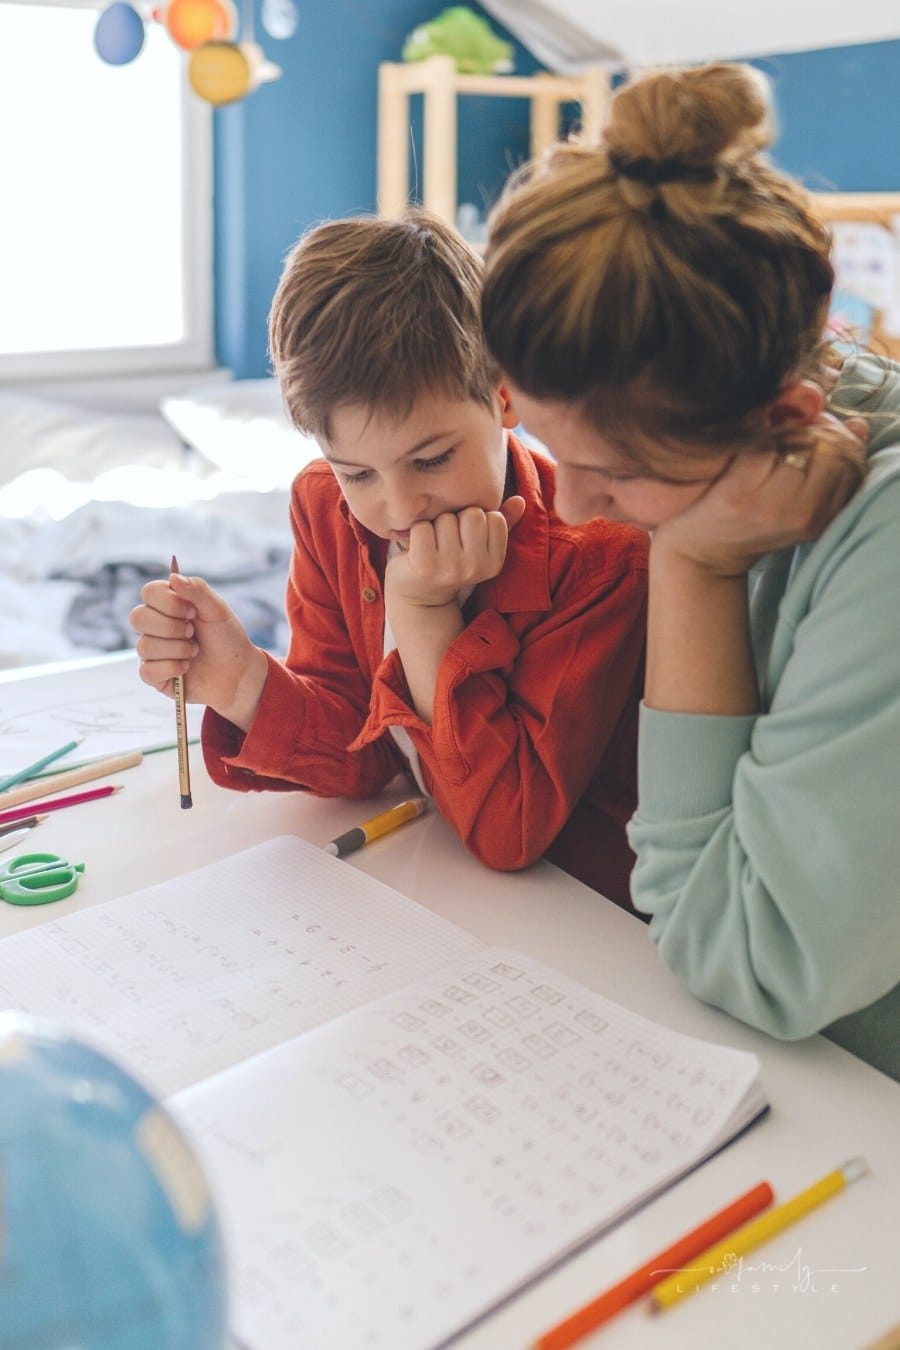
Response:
[[130, 572, 269, 730]]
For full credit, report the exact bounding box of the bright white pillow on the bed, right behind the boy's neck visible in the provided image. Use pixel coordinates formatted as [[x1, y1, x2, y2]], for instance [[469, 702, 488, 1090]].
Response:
[[159, 379, 321, 490]]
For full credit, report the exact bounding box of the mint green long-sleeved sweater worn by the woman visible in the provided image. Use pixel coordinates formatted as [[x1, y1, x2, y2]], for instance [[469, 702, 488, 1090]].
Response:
[[629, 358, 900, 1079]]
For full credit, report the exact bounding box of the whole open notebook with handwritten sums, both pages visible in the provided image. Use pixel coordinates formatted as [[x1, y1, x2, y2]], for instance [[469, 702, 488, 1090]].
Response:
[[0, 838, 765, 1350]]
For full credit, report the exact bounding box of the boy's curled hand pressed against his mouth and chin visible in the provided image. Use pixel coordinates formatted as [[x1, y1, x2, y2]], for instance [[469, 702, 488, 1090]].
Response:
[[385, 497, 525, 608]]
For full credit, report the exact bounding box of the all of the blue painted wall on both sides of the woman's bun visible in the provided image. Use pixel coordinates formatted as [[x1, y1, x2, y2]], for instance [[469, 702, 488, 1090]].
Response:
[[215, 17, 900, 377]]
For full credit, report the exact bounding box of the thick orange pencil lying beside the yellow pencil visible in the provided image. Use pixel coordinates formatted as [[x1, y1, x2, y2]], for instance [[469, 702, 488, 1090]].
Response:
[[532, 1181, 775, 1350]]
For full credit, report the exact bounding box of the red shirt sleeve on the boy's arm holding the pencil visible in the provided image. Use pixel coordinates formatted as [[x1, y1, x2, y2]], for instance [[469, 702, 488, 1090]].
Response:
[[202, 470, 406, 798]]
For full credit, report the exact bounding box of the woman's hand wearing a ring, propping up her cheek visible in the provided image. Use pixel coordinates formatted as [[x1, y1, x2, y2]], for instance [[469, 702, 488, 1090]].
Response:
[[653, 412, 868, 576]]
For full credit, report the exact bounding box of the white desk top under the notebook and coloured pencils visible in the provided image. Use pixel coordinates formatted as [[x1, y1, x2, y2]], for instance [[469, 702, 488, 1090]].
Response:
[[0, 666, 900, 1350]]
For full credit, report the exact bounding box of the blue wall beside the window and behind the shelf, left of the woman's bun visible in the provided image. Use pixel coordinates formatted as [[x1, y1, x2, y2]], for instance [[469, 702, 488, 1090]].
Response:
[[215, 0, 537, 377]]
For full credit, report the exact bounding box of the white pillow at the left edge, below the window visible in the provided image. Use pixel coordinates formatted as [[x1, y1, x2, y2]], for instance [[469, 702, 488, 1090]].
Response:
[[0, 389, 185, 485]]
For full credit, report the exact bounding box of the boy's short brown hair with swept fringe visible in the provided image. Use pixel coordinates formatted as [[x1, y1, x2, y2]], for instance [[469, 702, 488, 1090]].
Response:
[[269, 209, 499, 437]]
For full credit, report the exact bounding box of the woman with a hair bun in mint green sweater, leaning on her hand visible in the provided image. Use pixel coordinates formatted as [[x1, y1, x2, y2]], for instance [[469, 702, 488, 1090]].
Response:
[[483, 65, 900, 1077]]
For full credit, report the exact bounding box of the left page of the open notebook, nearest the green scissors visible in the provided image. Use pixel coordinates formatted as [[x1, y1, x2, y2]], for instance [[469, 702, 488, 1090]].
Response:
[[0, 837, 478, 1095]]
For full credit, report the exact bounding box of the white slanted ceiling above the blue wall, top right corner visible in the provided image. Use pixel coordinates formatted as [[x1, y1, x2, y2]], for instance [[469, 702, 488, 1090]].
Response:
[[480, 0, 900, 72]]
